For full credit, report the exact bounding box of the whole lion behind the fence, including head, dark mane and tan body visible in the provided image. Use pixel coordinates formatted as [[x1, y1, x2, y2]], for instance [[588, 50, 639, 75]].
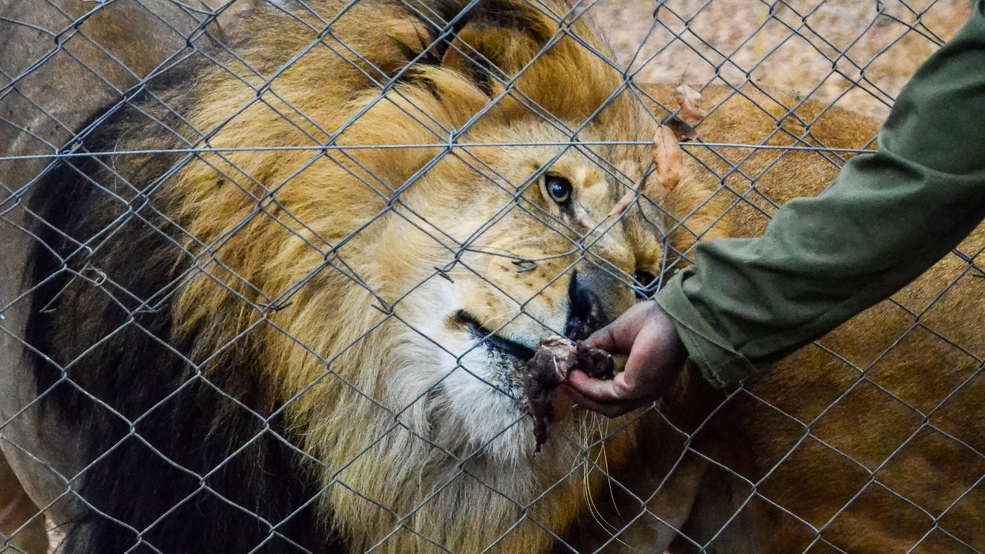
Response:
[[0, 0, 985, 554]]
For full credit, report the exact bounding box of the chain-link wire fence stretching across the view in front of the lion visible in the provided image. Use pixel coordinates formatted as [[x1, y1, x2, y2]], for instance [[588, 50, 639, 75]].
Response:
[[0, 0, 985, 554]]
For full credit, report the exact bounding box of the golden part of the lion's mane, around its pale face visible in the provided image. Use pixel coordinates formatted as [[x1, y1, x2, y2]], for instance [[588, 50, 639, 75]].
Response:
[[152, 0, 668, 553]]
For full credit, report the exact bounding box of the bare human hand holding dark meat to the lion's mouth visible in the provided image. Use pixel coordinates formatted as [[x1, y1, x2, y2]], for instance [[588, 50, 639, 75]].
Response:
[[563, 302, 687, 417]]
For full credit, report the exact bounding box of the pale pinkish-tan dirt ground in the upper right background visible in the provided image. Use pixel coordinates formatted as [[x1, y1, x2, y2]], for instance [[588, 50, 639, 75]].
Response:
[[583, 0, 973, 119]]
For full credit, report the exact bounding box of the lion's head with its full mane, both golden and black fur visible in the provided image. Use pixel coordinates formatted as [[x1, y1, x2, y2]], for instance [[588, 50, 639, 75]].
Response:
[[11, 0, 720, 553]]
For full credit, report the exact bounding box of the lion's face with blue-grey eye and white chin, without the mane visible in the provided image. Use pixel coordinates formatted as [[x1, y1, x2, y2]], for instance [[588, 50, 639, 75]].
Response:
[[378, 119, 662, 464]]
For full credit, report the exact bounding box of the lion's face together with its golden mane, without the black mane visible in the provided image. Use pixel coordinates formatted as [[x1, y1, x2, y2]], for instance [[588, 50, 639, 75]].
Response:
[[144, 3, 697, 552]]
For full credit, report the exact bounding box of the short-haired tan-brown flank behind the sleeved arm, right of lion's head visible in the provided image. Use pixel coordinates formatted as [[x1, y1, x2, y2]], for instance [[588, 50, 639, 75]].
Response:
[[636, 83, 985, 553]]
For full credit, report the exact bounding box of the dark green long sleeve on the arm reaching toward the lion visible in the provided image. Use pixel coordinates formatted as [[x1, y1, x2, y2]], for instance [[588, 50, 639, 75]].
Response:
[[656, 0, 985, 387]]
